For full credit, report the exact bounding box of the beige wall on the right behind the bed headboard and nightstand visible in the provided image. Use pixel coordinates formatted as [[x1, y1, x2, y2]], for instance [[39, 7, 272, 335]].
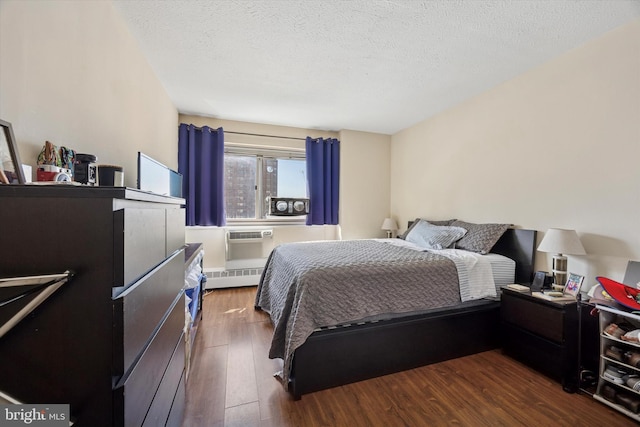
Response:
[[391, 20, 640, 286]]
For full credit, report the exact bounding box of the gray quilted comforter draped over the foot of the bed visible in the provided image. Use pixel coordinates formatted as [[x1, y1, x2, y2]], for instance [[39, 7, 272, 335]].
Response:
[[255, 240, 460, 388]]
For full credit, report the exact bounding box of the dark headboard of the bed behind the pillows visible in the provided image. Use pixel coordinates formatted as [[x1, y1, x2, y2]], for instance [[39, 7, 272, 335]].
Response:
[[409, 221, 538, 284]]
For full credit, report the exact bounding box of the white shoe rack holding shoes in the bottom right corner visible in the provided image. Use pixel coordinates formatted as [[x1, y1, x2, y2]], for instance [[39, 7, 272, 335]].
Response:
[[593, 305, 640, 422]]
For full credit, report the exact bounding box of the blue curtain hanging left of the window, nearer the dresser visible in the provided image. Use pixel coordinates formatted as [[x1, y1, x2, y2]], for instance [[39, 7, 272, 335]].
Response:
[[178, 123, 226, 226]]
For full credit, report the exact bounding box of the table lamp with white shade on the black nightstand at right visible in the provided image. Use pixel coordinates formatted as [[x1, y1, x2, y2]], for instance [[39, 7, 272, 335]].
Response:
[[538, 228, 587, 289]]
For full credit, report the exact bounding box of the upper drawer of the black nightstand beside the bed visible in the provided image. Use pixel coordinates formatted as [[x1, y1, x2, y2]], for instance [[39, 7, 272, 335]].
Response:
[[500, 294, 564, 343]]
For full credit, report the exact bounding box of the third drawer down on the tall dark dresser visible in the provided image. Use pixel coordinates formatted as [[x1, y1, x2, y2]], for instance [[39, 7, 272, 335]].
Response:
[[113, 292, 185, 427]]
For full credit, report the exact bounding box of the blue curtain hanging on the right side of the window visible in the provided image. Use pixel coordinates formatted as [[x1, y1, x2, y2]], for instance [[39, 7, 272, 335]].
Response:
[[306, 137, 340, 225]]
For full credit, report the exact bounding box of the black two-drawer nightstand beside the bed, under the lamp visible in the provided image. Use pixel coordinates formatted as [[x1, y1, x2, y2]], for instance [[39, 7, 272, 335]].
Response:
[[500, 288, 578, 393]]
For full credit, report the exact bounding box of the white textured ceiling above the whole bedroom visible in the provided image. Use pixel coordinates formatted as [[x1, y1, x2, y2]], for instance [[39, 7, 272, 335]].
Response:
[[114, 0, 640, 134]]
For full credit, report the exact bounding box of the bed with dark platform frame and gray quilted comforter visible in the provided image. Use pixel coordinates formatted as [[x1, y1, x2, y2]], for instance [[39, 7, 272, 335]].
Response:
[[255, 220, 536, 399]]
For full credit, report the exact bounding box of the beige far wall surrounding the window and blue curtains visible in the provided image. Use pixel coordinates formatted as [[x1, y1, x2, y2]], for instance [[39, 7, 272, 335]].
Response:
[[179, 114, 391, 268]]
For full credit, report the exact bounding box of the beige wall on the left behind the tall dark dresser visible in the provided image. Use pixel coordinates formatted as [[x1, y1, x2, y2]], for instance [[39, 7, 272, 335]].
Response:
[[0, 0, 178, 187]]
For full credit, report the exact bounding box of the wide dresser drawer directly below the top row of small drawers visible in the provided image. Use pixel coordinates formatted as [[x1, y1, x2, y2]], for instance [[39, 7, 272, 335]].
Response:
[[113, 251, 184, 376]]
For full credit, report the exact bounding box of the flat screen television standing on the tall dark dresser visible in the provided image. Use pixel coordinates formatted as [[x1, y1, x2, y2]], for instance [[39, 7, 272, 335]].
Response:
[[138, 151, 182, 197]]
